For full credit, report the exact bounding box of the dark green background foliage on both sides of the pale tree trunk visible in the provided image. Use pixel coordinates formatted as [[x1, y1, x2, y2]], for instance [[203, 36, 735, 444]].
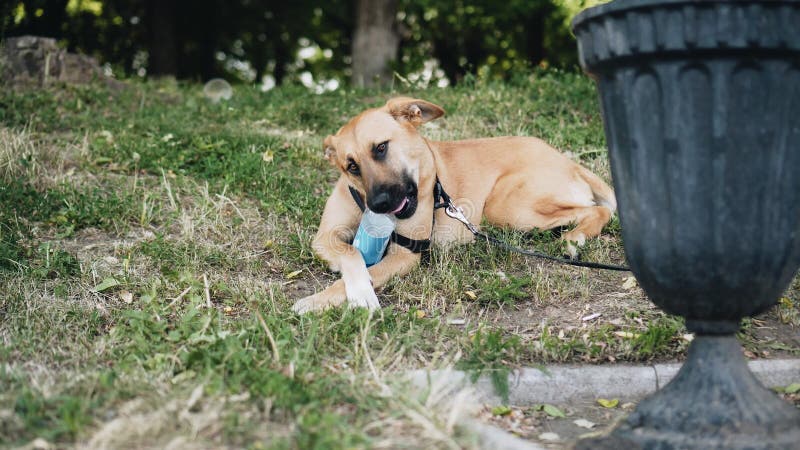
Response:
[[0, 0, 578, 84]]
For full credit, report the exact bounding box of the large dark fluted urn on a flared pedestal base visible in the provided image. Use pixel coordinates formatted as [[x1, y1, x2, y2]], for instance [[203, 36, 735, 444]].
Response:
[[573, 0, 800, 450]]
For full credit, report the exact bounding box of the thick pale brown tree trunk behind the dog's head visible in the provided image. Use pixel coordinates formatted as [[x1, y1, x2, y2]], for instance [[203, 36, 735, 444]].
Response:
[[351, 0, 400, 87]]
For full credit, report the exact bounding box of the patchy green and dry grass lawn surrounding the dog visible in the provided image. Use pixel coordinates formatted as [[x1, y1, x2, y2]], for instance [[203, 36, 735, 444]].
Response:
[[0, 72, 800, 448]]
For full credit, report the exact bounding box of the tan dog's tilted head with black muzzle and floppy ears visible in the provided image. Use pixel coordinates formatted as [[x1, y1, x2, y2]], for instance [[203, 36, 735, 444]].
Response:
[[323, 97, 444, 219]]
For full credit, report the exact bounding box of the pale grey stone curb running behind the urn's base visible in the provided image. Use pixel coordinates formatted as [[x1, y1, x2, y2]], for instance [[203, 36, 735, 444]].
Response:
[[409, 359, 800, 406]]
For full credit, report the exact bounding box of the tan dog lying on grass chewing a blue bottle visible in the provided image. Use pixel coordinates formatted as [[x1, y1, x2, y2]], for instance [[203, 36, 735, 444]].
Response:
[[293, 97, 617, 313]]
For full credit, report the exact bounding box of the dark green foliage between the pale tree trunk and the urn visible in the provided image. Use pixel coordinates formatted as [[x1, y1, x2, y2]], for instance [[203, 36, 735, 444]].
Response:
[[400, 0, 577, 84]]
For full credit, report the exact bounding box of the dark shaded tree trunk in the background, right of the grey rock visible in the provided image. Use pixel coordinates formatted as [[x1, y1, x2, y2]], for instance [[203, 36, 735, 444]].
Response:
[[147, 0, 178, 76]]
